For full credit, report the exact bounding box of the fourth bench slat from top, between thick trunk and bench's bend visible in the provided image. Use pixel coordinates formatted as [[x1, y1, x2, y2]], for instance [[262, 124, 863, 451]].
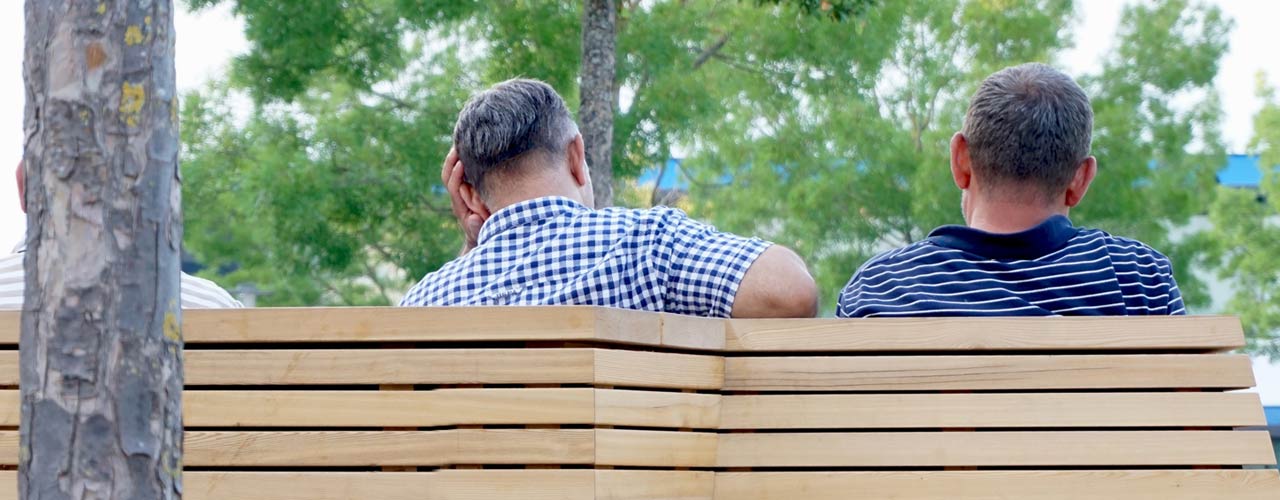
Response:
[[181, 428, 594, 467]]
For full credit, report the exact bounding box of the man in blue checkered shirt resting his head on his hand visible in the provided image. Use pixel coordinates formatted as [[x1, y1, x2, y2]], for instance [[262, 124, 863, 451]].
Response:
[[401, 79, 818, 317]]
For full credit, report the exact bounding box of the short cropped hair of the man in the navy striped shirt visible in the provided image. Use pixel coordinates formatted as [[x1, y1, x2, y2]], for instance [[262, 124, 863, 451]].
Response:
[[961, 63, 1093, 196]]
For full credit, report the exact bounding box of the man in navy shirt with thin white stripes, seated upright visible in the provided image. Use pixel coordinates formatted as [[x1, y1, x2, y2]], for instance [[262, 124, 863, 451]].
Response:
[[836, 64, 1187, 317]]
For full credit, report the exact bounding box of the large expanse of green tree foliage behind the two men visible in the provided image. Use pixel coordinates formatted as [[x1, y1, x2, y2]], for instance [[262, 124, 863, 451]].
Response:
[[183, 0, 1230, 317]]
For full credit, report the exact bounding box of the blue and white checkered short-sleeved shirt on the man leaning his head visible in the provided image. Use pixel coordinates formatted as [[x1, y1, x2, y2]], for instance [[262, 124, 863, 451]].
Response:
[[401, 197, 769, 317]]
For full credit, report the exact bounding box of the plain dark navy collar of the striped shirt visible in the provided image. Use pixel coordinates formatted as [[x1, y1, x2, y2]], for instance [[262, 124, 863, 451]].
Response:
[[929, 215, 1080, 260]]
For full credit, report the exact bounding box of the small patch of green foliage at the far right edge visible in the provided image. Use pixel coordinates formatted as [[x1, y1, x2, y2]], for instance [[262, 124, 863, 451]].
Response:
[[1210, 75, 1280, 359]]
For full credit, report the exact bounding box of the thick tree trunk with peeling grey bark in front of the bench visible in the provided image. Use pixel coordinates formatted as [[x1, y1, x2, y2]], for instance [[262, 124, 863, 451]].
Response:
[[18, 0, 182, 500]]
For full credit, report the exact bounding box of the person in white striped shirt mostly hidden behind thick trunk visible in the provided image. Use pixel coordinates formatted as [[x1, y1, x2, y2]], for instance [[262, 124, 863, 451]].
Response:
[[0, 161, 244, 309]]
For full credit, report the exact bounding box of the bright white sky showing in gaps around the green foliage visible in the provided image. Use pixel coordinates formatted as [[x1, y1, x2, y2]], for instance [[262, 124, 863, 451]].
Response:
[[0, 0, 1280, 405]]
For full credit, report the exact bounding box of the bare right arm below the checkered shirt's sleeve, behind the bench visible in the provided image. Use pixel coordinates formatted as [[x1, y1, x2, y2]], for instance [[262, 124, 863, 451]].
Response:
[[731, 244, 818, 317]]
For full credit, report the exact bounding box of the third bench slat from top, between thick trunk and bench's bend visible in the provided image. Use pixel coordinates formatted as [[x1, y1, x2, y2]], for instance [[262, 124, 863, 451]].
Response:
[[185, 387, 595, 428]]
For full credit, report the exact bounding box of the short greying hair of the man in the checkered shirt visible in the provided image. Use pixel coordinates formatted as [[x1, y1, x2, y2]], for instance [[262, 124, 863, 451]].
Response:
[[453, 79, 577, 196]]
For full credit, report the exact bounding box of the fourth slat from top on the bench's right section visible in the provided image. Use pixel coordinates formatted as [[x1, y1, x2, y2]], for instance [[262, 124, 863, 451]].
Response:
[[717, 431, 1275, 467]]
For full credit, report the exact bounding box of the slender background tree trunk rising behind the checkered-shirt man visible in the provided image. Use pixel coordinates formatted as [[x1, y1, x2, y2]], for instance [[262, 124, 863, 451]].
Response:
[[577, 0, 618, 207]]
